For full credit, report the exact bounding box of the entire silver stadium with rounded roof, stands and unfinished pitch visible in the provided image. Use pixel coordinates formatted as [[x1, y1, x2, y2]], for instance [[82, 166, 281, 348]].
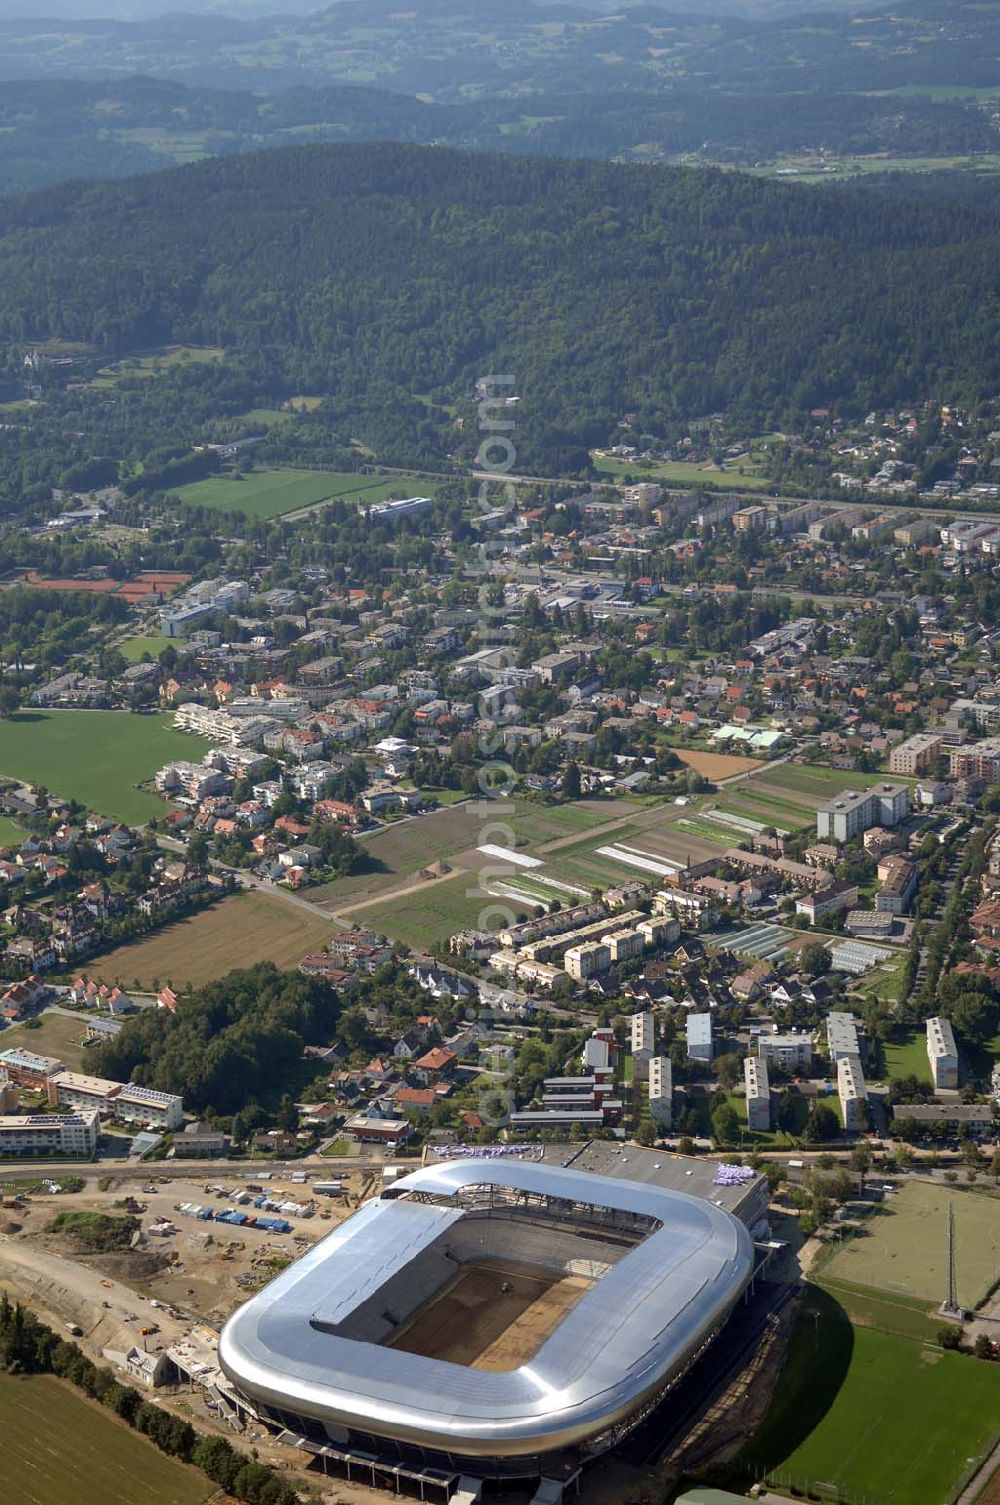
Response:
[[218, 1147, 756, 1474]]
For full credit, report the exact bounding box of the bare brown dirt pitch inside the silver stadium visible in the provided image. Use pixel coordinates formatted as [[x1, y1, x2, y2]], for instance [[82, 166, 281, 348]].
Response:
[[390, 1260, 593, 1373]]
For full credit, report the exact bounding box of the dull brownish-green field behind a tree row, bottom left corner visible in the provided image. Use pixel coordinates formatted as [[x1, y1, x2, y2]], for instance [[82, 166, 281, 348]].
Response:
[[0, 1374, 214, 1505]]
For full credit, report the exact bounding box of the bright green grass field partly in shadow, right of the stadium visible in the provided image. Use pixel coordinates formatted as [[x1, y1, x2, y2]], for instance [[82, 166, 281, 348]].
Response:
[[741, 1287, 1000, 1505]]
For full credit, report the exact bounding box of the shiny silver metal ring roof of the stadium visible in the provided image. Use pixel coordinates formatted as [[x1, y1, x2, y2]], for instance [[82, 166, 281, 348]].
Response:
[[218, 1160, 753, 1458]]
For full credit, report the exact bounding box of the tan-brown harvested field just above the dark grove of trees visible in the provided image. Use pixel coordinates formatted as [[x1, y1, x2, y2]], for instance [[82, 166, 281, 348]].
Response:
[[87, 892, 337, 990]]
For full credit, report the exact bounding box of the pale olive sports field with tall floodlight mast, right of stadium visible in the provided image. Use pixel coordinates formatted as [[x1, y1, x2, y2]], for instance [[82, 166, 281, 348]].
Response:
[[822, 1181, 1000, 1306]]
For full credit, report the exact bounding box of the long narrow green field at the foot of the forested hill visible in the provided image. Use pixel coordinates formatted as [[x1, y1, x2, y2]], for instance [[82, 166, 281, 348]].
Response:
[[173, 470, 440, 519]]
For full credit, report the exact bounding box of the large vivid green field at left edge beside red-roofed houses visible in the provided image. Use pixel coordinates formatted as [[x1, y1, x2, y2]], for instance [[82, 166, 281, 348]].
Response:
[[0, 710, 205, 825]]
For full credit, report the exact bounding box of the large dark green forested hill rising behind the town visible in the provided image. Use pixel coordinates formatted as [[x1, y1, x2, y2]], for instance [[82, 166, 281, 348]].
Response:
[[0, 144, 1000, 453]]
